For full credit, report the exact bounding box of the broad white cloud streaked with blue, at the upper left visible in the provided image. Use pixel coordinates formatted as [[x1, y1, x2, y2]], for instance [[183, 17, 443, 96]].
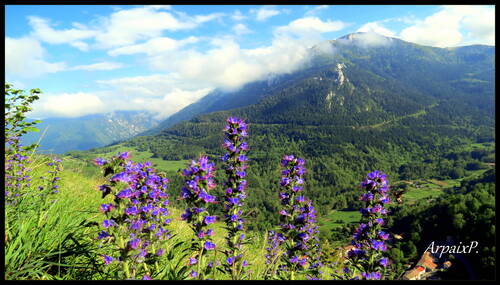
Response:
[[21, 5, 225, 51]]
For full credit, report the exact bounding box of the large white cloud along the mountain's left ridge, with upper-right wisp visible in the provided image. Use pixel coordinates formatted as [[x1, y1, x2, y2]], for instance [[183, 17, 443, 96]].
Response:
[[141, 17, 345, 90]]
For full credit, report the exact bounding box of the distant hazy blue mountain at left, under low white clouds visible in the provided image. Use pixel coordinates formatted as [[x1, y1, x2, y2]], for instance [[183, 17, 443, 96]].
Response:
[[23, 111, 158, 153]]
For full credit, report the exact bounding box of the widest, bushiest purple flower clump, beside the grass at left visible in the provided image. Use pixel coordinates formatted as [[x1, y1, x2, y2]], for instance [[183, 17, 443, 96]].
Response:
[[94, 152, 170, 280]]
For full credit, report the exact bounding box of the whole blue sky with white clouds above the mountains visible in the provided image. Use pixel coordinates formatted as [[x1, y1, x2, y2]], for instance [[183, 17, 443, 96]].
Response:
[[5, 5, 495, 119]]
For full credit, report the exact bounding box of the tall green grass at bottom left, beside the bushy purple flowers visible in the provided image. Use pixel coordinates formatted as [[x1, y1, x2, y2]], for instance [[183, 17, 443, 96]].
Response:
[[5, 156, 106, 279]]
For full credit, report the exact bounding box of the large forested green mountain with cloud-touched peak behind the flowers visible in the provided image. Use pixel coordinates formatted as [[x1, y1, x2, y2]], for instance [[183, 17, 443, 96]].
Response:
[[76, 33, 495, 227]]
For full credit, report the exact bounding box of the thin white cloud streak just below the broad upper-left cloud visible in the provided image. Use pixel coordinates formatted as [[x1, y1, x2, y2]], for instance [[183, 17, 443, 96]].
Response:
[[108, 37, 199, 56]]
